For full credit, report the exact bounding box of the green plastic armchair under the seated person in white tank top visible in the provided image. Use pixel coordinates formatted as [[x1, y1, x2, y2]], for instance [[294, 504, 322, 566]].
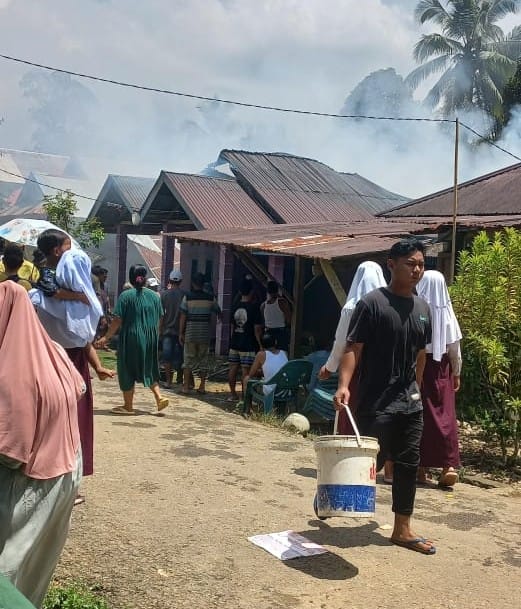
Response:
[[243, 359, 313, 414]]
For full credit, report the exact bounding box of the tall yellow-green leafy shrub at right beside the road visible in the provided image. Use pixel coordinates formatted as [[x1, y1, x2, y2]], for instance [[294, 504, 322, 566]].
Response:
[[451, 229, 521, 462]]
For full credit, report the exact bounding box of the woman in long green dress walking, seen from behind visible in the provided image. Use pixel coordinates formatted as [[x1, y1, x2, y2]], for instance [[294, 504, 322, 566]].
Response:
[[96, 265, 168, 414]]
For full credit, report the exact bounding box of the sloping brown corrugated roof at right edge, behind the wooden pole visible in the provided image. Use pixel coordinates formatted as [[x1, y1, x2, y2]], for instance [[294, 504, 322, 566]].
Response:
[[380, 163, 521, 217]]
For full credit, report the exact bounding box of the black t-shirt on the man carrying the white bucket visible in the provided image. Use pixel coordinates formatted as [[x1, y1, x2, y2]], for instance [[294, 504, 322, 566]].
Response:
[[347, 288, 432, 417]]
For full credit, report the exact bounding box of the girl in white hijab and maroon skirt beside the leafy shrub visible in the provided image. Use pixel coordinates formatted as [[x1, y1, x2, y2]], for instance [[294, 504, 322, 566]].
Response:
[[416, 271, 462, 486]]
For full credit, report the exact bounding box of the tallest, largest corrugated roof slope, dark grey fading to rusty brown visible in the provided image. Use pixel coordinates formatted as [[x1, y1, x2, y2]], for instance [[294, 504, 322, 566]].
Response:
[[220, 150, 378, 223]]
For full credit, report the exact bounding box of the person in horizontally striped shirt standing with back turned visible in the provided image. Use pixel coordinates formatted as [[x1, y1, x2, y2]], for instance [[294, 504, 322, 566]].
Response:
[[179, 273, 221, 394]]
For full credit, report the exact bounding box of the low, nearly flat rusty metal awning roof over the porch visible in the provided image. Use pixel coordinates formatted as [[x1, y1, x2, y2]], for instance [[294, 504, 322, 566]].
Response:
[[168, 215, 521, 260]]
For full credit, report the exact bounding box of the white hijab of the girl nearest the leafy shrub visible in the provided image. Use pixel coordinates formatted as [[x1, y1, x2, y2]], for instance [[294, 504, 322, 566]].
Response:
[[416, 271, 462, 362]]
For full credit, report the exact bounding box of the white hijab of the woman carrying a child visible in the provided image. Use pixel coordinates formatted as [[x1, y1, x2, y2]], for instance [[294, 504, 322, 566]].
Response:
[[30, 249, 103, 343]]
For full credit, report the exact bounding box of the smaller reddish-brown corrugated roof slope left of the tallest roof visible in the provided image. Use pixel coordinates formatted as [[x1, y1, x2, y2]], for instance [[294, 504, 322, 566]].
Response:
[[165, 172, 271, 229]]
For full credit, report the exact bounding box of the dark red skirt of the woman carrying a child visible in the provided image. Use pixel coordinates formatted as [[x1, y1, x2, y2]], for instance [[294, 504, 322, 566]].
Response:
[[66, 347, 94, 476]]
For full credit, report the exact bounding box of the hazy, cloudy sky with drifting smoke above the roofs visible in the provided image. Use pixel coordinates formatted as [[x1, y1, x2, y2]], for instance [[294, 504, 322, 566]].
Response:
[[0, 0, 521, 205]]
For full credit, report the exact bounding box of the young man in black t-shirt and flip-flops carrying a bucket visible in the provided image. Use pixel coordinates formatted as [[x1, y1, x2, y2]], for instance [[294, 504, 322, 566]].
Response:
[[334, 239, 436, 554]]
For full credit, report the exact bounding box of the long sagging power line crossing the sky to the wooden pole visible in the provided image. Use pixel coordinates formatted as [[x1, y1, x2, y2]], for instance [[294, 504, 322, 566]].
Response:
[[0, 54, 456, 123]]
